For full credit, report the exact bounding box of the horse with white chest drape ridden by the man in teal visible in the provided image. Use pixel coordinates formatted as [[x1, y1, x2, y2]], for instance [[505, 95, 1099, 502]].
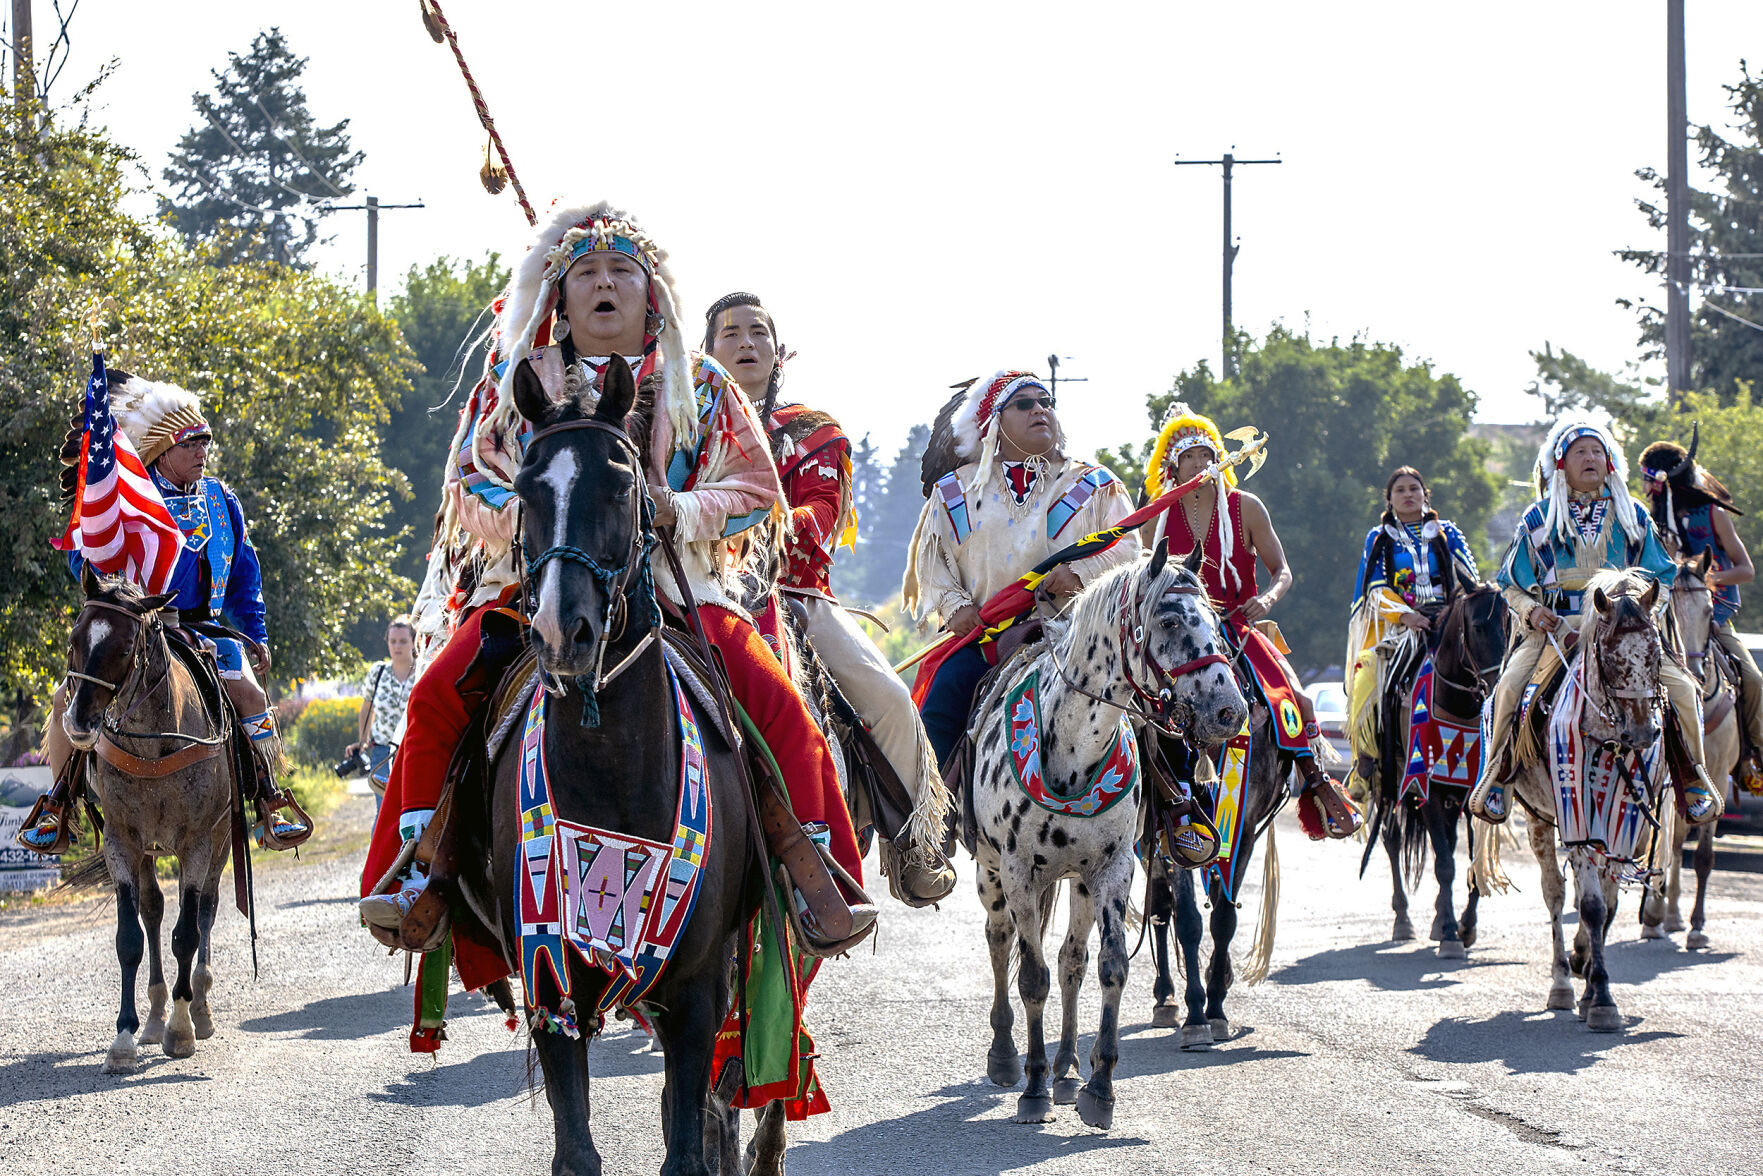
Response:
[[1476, 569, 1671, 1033]]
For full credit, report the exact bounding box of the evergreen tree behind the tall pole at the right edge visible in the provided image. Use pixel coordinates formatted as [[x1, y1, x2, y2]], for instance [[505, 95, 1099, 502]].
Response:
[[1617, 60, 1763, 400]]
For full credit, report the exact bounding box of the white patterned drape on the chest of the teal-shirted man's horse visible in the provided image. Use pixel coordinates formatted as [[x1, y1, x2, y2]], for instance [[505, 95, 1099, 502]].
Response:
[[1548, 658, 1664, 882]]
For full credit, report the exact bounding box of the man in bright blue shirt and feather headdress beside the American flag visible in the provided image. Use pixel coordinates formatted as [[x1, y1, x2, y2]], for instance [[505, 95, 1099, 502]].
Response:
[[19, 372, 312, 853]]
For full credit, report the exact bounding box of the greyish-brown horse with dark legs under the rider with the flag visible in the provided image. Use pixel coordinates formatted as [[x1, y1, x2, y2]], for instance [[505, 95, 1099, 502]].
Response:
[[62, 569, 233, 1074]]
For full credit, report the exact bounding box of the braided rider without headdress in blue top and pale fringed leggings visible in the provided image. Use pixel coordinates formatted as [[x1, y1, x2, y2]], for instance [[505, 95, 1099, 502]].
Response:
[[1347, 465, 1481, 797]]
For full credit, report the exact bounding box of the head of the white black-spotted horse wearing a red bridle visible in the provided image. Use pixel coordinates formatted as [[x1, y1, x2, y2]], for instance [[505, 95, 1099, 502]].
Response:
[[1074, 540, 1248, 744]]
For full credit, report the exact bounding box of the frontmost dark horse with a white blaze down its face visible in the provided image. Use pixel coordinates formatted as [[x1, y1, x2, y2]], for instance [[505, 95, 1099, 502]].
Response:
[[447, 360, 760, 1176]]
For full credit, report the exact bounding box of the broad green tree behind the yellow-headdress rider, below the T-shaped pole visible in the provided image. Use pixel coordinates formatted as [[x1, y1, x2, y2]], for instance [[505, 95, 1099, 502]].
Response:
[[1148, 326, 1499, 668]]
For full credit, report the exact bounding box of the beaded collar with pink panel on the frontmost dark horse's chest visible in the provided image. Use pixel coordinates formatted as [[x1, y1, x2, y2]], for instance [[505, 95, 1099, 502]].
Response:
[[515, 665, 710, 1037]]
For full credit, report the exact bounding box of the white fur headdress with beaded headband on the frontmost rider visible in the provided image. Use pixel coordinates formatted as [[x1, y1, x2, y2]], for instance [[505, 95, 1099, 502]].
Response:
[[462, 201, 698, 488]]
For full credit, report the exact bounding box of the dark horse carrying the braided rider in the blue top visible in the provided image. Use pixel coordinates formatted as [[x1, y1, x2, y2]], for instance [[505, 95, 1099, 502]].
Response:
[[1359, 584, 1507, 959]]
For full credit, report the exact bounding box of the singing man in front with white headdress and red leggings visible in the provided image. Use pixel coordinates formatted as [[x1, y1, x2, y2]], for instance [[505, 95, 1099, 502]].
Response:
[[360, 203, 862, 952]]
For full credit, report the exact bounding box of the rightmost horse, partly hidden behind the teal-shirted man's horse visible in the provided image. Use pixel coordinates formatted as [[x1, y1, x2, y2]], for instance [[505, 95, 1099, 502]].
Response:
[[1641, 550, 1740, 949]]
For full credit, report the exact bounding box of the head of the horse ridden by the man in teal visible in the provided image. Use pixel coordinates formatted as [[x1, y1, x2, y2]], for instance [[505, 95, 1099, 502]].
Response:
[[1580, 573, 1664, 749]]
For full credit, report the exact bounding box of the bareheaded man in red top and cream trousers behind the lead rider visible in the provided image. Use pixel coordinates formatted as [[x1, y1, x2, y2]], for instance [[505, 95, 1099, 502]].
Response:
[[703, 293, 956, 906]]
